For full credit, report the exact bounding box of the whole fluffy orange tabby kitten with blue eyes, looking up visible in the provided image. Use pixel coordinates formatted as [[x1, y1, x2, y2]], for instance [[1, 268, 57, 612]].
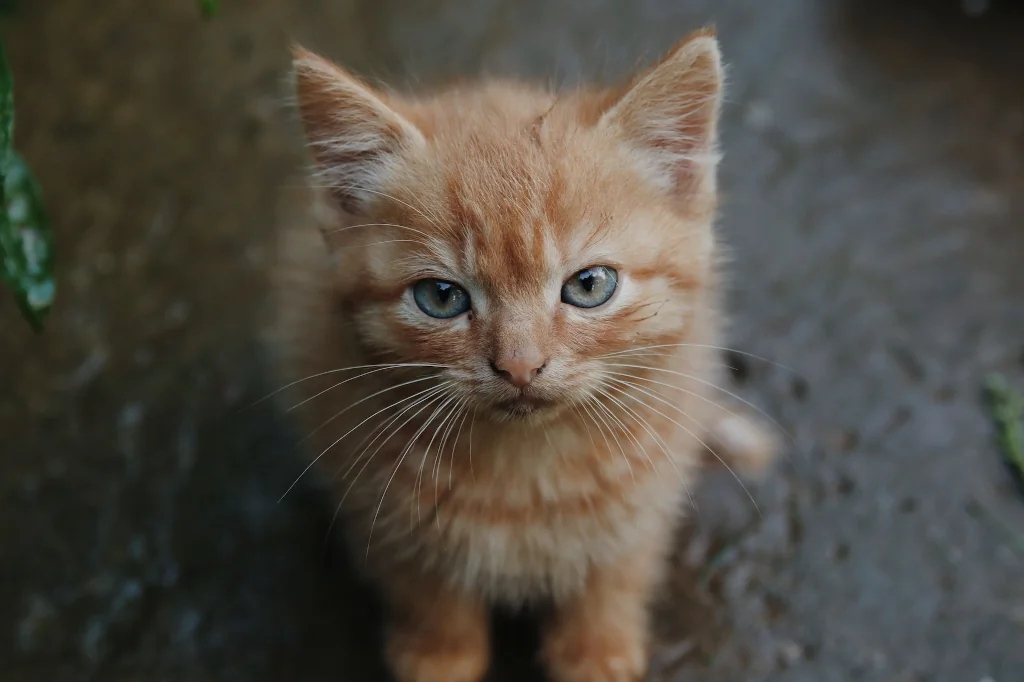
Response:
[[273, 32, 761, 682]]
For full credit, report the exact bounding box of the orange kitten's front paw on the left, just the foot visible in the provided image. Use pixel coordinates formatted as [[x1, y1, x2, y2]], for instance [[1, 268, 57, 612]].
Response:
[[387, 629, 489, 682]]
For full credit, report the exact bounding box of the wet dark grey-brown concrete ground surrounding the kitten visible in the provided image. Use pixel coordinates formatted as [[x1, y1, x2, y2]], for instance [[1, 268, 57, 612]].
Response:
[[0, 0, 1024, 682]]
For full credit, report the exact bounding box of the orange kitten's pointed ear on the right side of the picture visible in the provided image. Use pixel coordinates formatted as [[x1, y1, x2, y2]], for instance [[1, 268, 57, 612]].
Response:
[[599, 30, 723, 196]]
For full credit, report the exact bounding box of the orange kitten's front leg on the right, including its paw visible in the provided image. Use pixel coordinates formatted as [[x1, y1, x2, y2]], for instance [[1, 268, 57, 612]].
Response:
[[542, 551, 660, 682]]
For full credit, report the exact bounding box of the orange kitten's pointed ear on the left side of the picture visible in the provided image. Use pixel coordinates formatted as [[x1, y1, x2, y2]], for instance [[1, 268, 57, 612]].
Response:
[[292, 46, 425, 214]]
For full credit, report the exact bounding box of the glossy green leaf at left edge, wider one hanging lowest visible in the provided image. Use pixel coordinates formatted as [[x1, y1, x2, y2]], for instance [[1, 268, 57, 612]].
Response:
[[0, 150, 56, 331]]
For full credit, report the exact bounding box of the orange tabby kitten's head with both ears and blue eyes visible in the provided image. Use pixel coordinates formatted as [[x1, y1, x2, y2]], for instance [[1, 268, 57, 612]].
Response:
[[295, 33, 722, 419]]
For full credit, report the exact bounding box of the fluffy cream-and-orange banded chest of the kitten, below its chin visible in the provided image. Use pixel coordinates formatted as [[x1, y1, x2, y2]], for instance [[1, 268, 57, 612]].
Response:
[[413, 436, 680, 602]]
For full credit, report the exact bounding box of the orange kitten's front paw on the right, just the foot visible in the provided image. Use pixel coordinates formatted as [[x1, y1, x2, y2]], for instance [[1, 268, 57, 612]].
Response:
[[542, 621, 647, 682]]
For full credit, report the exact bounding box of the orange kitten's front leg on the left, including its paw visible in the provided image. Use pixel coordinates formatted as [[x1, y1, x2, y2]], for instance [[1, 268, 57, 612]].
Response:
[[385, 576, 490, 682]]
